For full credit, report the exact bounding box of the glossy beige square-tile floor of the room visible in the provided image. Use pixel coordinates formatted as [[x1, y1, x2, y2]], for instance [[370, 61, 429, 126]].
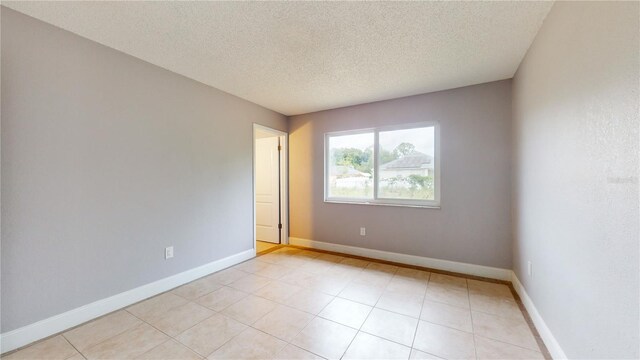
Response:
[[5, 247, 546, 360]]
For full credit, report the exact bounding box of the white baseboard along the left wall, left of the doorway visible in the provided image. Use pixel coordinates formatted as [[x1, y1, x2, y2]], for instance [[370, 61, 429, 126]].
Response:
[[0, 249, 256, 353]]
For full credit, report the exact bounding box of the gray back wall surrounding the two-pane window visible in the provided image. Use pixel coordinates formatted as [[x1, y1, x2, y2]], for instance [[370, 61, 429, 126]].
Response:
[[289, 80, 511, 268]]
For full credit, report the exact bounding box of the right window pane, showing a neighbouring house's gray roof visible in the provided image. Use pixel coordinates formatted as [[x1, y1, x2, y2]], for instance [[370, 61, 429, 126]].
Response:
[[378, 126, 435, 200]]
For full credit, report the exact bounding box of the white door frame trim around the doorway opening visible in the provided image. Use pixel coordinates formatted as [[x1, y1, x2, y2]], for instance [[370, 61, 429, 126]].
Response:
[[251, 123, 289, 252]]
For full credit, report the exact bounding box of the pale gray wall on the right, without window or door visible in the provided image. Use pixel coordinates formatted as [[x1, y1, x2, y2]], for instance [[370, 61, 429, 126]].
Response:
[[513, 2, 640, 359]]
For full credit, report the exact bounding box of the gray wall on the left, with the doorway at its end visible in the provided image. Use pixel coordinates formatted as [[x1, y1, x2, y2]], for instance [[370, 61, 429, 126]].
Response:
[[1, 8, 286, 332]]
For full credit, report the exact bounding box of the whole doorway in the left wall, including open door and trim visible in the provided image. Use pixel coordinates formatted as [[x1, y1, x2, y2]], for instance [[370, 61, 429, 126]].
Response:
[[253, 124, 288, 252]]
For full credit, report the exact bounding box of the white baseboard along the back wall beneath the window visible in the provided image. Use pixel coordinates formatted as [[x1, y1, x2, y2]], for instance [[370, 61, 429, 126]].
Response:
[[289, 237, 512, 281]]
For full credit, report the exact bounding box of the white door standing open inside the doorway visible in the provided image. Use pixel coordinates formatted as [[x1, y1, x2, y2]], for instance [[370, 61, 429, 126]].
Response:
[[256, 136, 280, 244]]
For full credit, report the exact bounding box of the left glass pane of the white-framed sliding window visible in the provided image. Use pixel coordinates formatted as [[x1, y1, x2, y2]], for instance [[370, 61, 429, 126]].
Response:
[[326, 132, 373, 199]]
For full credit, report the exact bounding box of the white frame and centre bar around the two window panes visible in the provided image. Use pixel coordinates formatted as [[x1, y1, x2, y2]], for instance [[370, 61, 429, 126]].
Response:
[[323, 121, 441, 209]]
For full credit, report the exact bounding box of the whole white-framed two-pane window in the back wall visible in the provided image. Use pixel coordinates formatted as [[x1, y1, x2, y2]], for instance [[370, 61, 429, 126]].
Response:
[[325, 123, 440, 207]]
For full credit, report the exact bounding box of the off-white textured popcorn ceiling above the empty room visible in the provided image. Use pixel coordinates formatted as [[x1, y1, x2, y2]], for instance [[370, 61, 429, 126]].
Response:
[[2, 1, 553, 115]]
